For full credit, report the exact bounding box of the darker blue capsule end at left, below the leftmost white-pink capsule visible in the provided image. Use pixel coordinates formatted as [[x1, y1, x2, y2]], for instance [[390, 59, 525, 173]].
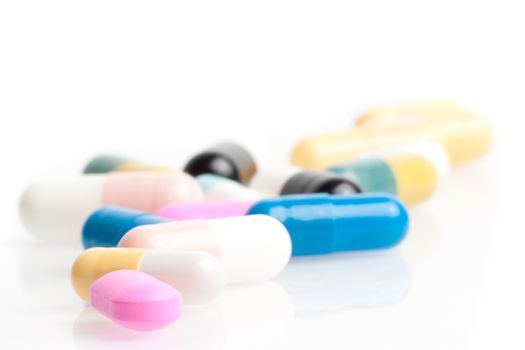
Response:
[[82, 206, 173, 249]]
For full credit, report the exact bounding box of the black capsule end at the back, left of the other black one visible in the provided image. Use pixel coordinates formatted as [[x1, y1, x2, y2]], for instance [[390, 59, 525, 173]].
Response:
[[184, 142, 257, 184]]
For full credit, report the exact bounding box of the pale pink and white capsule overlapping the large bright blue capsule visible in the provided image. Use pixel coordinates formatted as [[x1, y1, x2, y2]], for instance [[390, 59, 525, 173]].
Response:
[[119, 215, 292, 283]]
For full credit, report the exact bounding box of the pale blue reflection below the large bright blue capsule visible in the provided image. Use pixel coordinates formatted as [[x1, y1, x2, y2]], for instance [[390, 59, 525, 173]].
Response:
[[277, 250, 412, 317]]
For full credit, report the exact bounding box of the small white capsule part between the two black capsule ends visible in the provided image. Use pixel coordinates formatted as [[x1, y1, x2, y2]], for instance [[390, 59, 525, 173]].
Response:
[[249, 164, 302, 198]]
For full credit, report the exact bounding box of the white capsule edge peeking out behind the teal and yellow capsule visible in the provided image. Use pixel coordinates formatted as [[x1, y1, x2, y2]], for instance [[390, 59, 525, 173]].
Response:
[[358, 142, 451, 185]]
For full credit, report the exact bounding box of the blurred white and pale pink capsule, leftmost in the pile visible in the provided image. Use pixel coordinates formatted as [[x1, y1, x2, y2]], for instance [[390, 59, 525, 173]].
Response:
[[19, 172, 204, 242]]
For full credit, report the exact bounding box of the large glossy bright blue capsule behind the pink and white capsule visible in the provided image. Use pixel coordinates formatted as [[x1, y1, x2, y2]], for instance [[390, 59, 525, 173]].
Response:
[[247, 194, 409, 255]]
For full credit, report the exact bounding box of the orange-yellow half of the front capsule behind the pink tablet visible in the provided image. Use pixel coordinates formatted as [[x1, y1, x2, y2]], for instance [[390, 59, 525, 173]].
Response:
[[71, 248, 145, 301]]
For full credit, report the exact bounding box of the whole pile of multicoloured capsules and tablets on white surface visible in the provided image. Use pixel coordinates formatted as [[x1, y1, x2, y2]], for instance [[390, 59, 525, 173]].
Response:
[[20, 102, 491, 331]]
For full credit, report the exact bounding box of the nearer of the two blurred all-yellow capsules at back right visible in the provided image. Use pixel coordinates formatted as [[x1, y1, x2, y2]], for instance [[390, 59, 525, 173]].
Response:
[[291, 108, 492, 169]]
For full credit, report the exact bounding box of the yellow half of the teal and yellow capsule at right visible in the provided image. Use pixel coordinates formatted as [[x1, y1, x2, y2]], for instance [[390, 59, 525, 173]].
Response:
[[384, 155, 439, 205]]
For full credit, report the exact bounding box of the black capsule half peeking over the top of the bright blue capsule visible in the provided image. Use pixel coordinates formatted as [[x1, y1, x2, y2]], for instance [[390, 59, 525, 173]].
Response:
[[281, 170, 363, 195]]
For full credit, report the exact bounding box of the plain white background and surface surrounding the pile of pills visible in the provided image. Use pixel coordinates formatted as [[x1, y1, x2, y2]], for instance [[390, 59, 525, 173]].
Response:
[[0, 0, 525, 349]]
